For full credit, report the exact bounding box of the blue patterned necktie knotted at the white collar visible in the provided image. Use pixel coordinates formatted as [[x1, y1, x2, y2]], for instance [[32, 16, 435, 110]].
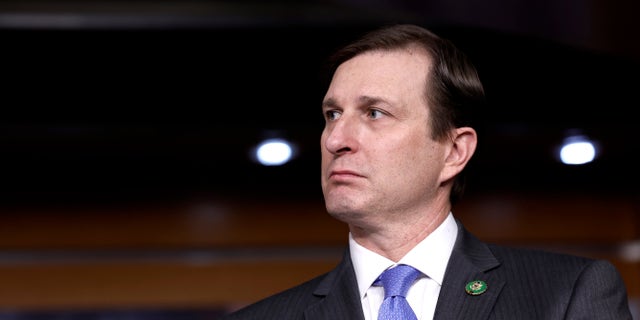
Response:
[[373, 264, 420, 320]]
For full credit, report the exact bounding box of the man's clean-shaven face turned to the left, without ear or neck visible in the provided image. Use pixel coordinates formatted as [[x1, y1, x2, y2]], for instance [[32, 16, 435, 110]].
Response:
[[321, 49, 447, 228]]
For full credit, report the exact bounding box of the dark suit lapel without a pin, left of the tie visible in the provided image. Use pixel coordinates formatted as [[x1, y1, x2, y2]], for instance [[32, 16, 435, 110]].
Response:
[[304, 249, 364, 320]]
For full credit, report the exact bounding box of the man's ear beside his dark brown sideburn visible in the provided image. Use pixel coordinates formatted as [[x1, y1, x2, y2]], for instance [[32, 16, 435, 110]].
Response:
[[440, 127, 478, 182]]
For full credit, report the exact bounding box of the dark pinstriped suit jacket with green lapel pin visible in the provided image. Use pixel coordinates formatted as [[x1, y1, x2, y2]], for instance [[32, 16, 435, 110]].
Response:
[[223, 222, 632, 320]]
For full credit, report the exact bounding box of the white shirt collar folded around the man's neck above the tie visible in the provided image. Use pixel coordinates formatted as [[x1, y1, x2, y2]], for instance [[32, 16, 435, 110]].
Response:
[[349, 212, 458, 298]]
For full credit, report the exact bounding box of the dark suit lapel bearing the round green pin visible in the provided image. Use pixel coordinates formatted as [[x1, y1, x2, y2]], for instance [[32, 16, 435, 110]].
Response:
[[434, 222, 505, 320]]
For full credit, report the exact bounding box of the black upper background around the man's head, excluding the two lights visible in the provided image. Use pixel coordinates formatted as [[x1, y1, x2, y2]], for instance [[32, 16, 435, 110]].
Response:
[[0, 1, 640, 205]]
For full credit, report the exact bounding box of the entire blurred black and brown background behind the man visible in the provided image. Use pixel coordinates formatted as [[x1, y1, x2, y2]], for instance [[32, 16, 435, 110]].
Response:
[[0, 0, 640, 320]]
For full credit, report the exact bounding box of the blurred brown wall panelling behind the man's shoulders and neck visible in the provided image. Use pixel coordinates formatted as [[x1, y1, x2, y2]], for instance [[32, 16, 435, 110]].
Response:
[[0, 194, 640, 316]]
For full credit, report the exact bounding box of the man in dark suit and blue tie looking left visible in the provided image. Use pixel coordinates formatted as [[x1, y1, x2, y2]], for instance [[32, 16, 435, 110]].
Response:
[[226, 25, 631, 320]]
